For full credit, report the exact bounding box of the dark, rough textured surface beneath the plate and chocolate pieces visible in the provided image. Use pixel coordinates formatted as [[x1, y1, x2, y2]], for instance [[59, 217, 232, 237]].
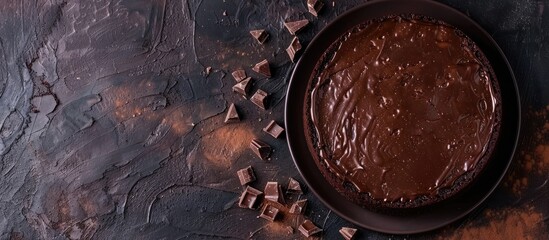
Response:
[[0, 0, 549, 239]]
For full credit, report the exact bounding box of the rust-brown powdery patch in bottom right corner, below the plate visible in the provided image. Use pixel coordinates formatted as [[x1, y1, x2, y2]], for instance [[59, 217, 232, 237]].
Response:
[[446, 207, 545, 240]]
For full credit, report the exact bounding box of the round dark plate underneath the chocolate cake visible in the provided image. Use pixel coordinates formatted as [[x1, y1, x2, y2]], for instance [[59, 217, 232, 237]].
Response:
[[285, 0, 520, 234]]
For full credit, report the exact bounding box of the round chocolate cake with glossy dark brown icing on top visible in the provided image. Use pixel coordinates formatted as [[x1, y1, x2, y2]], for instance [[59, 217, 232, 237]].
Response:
[[304, 16, 501, 208]]
